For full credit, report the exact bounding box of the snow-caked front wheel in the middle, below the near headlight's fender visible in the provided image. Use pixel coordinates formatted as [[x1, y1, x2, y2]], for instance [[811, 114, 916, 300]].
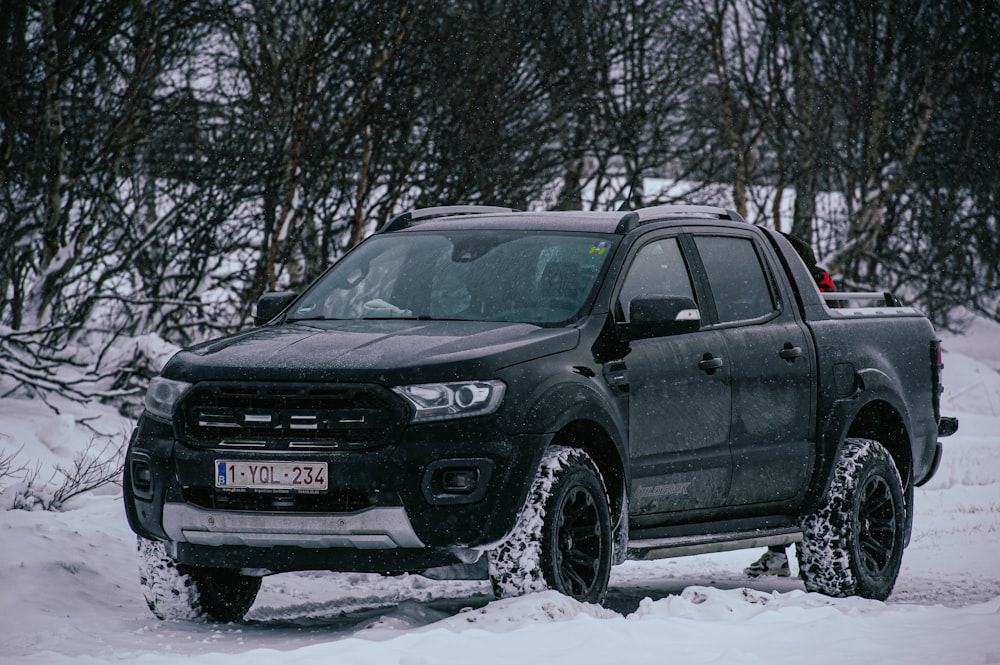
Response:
[[487, 446, 613, 603]]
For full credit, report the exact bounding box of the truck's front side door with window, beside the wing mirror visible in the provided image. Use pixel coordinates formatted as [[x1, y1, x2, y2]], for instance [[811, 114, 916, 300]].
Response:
[[615, 235, 732, 515]]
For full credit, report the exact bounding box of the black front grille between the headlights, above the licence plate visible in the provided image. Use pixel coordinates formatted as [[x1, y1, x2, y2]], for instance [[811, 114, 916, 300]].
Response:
[[177, 382, 408, 450]]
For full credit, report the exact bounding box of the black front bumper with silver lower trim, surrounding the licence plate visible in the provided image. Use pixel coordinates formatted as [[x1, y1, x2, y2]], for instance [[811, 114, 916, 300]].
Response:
[[124, 416, 549, 572]]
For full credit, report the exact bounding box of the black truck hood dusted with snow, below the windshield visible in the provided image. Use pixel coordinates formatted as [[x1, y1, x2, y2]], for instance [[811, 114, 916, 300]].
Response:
[[162, 320, 580, 385]]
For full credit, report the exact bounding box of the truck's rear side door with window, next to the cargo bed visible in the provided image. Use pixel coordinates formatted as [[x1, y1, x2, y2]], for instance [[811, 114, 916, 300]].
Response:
[[691, 230, 815, 505]]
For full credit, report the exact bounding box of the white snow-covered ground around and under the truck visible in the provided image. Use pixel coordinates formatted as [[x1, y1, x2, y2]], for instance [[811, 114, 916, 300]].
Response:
[[0, 321, 1000, 665]]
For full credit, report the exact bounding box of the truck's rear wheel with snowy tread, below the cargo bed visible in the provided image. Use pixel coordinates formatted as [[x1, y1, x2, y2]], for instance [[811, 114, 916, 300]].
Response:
[[796, 439, 907, 600]]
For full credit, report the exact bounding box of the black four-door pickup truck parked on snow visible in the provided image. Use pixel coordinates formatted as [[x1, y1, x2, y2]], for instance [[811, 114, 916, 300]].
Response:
[[124, 206, 957, 620]]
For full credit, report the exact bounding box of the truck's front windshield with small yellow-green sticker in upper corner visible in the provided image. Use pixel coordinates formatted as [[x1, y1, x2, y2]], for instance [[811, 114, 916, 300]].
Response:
[[288, 231, 617, 325]]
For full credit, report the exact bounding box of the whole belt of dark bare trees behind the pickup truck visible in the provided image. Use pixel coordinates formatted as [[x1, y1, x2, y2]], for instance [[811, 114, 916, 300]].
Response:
[[0, 0, 1000, 397]]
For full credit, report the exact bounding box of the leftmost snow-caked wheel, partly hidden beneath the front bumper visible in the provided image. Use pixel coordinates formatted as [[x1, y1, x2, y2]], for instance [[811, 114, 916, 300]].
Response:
[[139, 537, 261, 622]]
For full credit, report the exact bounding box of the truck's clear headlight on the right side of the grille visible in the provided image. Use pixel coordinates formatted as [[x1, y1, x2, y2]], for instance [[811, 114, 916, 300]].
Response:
[[393, 381, 507, 422]]
